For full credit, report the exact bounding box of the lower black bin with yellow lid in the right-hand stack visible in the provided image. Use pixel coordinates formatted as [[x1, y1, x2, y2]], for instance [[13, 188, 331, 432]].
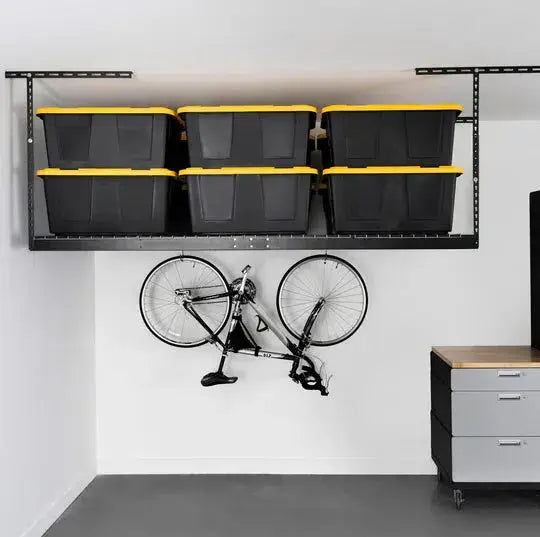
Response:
[[323, 166, 462, 233]]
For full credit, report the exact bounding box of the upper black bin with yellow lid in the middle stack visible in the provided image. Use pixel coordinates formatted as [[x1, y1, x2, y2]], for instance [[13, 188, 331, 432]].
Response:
[[178, 105, 317, 168]]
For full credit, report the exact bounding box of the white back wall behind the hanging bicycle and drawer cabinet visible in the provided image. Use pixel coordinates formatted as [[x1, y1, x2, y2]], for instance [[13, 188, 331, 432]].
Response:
[[96, 122, 540, 473]]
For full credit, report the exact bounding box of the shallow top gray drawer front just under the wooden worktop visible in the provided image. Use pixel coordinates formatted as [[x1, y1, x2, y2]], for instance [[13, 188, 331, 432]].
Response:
[[452, 368, 540, 392]]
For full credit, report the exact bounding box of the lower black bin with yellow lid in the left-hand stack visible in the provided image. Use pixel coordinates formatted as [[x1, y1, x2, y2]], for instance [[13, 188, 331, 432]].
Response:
[[37, 168, 176, 235]]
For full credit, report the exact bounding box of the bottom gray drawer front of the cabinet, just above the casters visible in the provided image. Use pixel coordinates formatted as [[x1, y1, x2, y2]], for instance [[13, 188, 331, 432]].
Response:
[[452, 436, 540, 483]]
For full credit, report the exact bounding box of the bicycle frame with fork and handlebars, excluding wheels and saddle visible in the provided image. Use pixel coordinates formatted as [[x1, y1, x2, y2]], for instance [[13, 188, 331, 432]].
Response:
[[184, 265, 327, 395]]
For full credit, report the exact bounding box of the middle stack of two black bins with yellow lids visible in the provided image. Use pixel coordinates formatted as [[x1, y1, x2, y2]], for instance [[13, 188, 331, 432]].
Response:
[[178, 105, 317, 234]]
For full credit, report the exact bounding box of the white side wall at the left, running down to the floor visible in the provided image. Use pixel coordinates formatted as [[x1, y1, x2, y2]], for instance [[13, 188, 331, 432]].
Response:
[[0, 79, 96, 537]]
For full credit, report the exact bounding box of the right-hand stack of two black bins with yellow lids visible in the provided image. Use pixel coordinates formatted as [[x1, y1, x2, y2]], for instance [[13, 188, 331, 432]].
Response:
[[321, 104, 462, 233]]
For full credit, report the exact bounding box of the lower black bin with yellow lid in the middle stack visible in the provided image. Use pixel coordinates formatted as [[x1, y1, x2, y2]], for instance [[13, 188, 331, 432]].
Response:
[[179, 166, 317, 234]]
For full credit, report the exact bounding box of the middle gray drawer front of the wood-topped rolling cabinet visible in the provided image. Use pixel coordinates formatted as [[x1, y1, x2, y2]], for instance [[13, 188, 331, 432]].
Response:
[[452, 392, 540, 436]]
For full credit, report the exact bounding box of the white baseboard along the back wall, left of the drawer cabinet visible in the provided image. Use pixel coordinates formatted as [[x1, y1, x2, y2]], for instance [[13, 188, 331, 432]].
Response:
[[98, 457, 435, 475]]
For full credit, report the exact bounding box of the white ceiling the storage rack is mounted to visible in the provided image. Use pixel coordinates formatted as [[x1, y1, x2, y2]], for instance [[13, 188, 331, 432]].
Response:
[[0, 0, 540, 120]]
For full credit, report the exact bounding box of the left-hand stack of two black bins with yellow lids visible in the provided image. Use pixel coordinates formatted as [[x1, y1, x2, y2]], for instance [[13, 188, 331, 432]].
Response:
[[37, 107, 186, 235]]
